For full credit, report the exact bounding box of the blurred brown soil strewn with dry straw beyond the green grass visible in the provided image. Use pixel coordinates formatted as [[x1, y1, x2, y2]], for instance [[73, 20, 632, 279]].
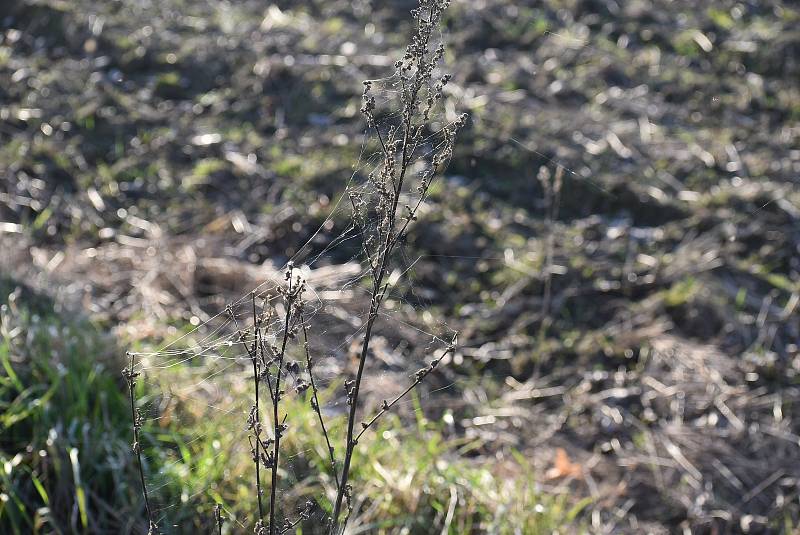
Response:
[[0, 0, 800, 533]]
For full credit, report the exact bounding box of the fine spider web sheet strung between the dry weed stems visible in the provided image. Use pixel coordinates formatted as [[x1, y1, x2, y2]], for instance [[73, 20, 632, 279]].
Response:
[[126, 67, 462, 529]]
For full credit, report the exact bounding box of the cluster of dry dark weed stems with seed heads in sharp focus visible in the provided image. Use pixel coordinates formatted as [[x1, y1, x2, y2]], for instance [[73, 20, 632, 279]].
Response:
[[125, 0, 466, 535]]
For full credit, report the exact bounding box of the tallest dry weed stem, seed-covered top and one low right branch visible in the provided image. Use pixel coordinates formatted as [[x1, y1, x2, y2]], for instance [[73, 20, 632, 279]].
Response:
[[330, 0, 466, 533]]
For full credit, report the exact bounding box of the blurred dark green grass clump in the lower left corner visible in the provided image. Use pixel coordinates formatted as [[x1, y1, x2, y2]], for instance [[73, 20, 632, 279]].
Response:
[[0, 281, 139, 534]]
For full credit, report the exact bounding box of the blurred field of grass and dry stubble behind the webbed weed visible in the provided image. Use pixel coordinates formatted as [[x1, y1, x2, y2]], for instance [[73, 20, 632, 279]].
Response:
[[0, 0, 800, 533]]
